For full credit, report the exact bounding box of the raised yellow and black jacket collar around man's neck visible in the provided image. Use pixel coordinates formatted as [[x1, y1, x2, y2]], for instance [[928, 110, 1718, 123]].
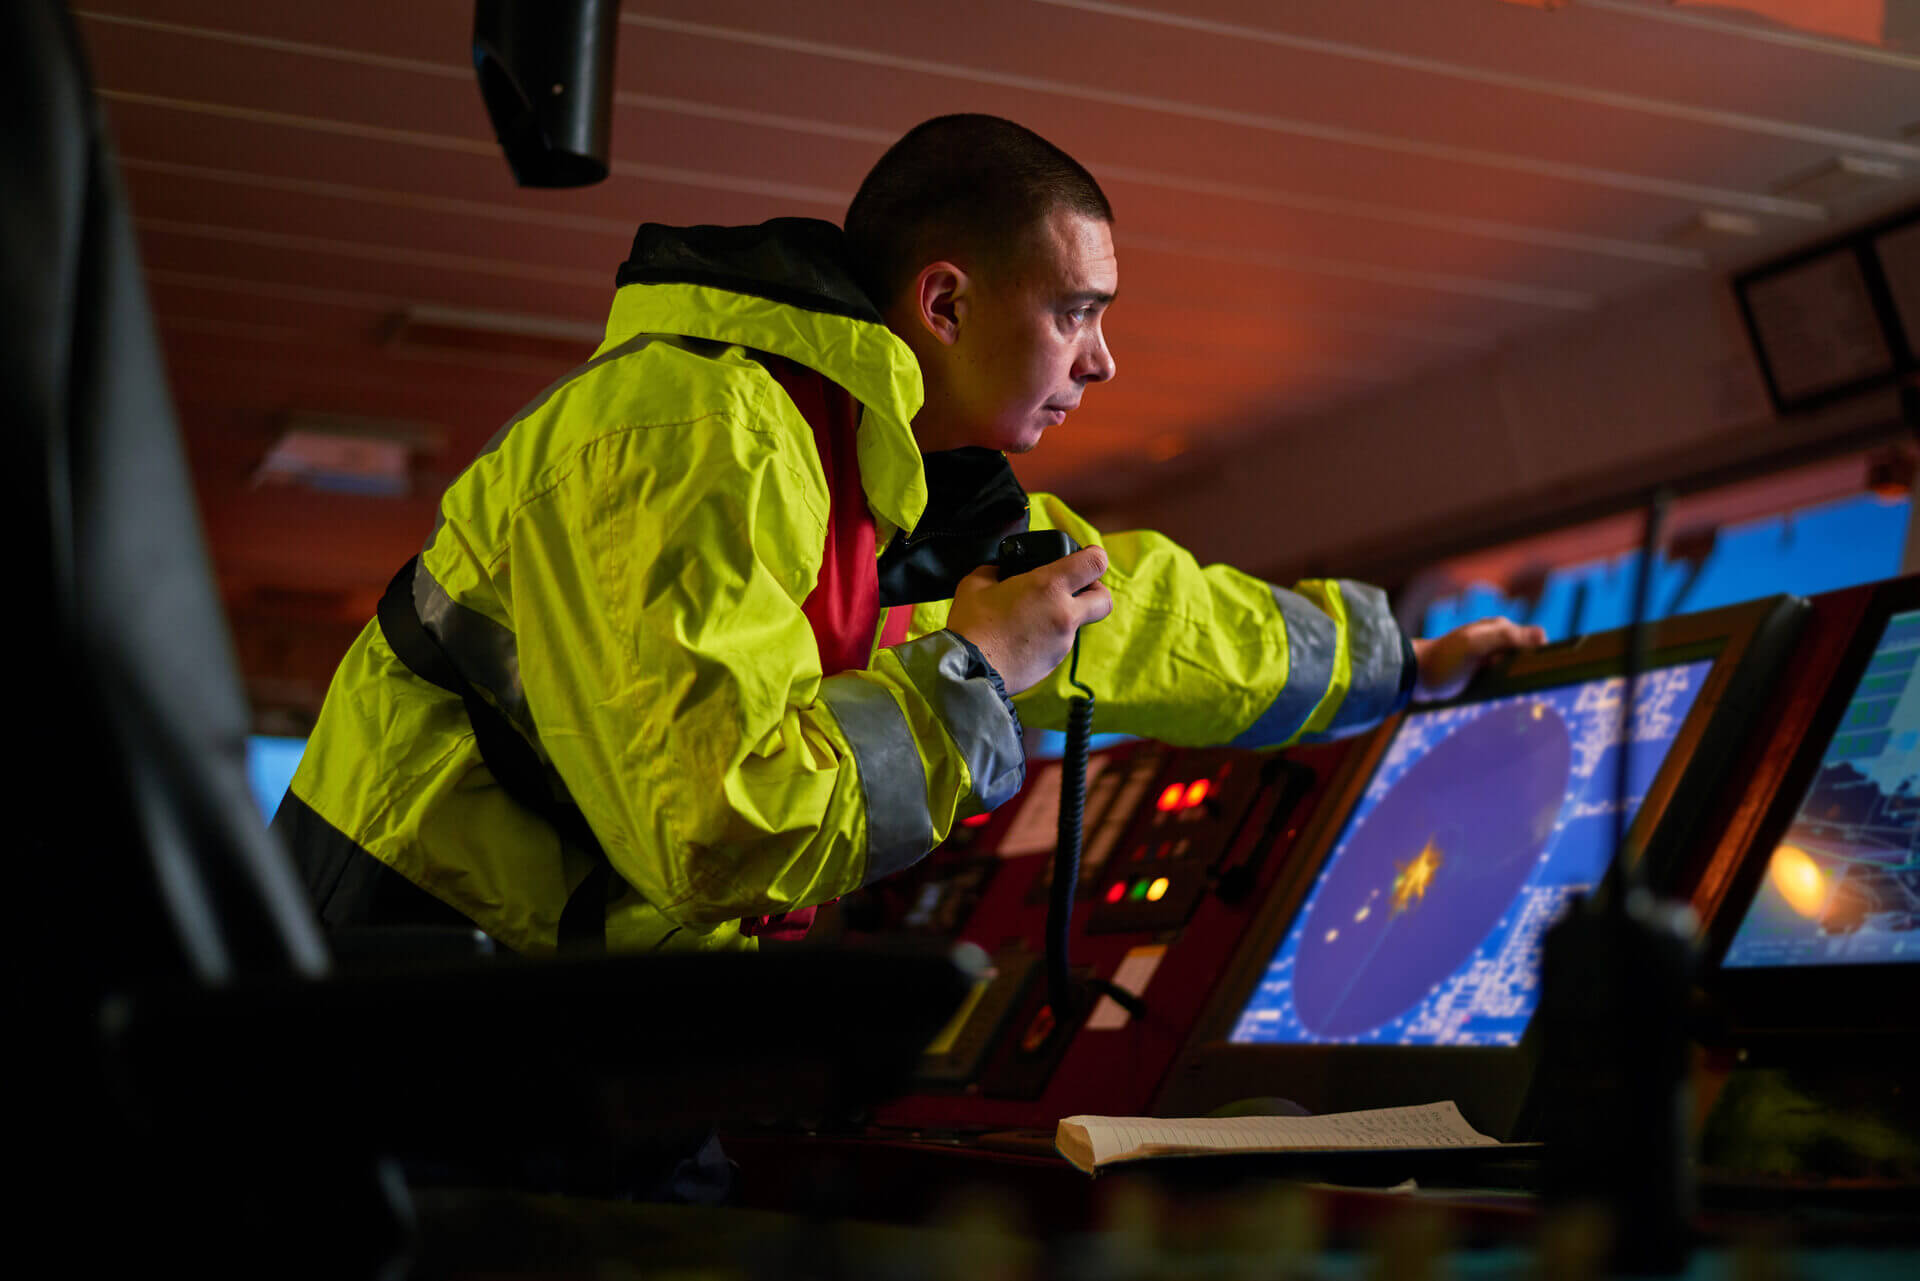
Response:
[[601, 219, 927, 530]]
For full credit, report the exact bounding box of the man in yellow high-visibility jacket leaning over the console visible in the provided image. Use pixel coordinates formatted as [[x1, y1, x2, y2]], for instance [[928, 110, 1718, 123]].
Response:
[[275, 115, 1540, 953]]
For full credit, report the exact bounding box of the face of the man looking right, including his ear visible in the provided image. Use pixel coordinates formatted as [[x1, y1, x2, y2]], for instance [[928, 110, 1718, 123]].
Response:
[[914, 209, 1119, 453]]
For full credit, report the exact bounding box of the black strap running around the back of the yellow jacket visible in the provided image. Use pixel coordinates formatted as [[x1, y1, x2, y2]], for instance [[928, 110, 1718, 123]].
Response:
[[378, 557, 624, 949]]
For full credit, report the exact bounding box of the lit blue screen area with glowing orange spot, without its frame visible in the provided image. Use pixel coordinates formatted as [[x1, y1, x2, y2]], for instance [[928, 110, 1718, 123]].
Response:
[[1720, 611, 1920, 970]]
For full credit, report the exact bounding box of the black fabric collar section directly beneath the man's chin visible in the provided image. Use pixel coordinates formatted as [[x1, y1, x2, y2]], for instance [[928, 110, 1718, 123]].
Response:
[[879, 447, 1027, 605]]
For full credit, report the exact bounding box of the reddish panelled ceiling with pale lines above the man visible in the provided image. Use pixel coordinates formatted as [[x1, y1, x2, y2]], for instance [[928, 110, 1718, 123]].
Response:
[[75, 0, 1920, 718]]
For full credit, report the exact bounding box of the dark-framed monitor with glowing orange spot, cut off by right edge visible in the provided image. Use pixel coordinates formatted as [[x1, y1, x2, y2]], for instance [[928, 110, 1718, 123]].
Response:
[[1709, 578, 1920, 1045]]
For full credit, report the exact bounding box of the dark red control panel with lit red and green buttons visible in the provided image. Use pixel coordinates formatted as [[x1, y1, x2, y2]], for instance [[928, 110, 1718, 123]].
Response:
[[843, 741, 1348, 1131]]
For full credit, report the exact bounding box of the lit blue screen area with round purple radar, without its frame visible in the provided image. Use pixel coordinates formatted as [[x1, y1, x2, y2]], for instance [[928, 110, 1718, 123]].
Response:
[[1231, 659, 1713, 1045]]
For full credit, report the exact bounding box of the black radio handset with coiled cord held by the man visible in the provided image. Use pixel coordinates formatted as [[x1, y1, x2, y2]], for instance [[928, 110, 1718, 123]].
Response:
[[995, 530, 1146, 1035]]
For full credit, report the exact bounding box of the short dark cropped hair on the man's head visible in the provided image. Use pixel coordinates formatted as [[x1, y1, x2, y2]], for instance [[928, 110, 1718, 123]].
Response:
[[847, 115, 1114, 309]]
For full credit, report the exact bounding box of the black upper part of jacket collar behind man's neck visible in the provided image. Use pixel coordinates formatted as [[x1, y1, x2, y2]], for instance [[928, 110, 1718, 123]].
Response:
[[614, 217, 879, 325]]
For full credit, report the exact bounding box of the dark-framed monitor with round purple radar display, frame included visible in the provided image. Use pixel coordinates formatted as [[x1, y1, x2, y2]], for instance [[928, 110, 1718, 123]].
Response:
[[1156, 597, 1805, 1137]]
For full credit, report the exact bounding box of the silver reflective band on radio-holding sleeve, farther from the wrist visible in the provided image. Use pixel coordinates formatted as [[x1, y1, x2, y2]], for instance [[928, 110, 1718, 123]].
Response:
[[820, 672, 933, 883]]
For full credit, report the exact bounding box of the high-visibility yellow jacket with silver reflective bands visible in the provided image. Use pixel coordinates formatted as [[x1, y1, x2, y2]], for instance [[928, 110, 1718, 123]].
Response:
[[288, 221, 1411, 953]]
